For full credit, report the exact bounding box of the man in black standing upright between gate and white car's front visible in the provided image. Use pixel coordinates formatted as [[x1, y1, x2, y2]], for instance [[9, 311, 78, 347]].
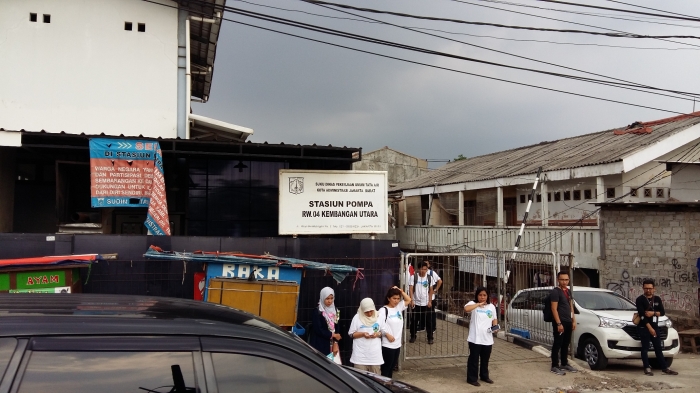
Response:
[[549, 272, 577, 375]]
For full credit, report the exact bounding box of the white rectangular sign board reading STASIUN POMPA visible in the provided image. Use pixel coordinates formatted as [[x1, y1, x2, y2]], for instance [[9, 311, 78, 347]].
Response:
[[279, 169, 389, 235]]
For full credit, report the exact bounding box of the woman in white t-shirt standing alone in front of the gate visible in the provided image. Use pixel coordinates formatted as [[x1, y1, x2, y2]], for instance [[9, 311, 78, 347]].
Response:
[[464, 287, 498, 386]]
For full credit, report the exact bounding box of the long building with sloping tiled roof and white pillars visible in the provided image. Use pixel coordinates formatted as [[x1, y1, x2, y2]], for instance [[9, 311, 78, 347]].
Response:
[[390, 112, 700, 281]]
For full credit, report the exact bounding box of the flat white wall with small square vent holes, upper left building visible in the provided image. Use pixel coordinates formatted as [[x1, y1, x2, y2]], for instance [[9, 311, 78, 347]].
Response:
[[0, 0, 177, 138]]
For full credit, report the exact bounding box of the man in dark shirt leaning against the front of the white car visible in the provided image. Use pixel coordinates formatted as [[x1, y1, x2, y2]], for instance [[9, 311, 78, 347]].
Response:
[[635, 278, 678, 375]]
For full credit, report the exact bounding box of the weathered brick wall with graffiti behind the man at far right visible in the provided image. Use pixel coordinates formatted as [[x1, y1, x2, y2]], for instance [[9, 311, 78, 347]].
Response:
[[600, 207, 700, 321]]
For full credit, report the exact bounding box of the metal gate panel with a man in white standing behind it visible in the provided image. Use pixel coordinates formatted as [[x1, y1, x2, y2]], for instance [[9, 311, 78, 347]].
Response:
[[401, 253, 486, 360]]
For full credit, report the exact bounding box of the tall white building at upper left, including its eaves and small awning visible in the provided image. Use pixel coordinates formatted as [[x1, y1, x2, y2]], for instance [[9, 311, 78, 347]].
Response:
[[0, 0, 252, 141]]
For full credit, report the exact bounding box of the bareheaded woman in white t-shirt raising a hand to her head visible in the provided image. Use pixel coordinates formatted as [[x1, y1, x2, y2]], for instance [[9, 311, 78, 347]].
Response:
[[379, 286, 411, 378]]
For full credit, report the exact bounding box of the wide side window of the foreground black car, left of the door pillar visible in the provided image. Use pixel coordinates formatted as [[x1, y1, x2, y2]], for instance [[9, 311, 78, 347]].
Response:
[[19, 351, 195, 393]]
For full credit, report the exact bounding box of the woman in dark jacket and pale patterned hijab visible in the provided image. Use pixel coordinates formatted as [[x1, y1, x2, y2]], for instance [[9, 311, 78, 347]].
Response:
[[309, 287, 340, 356]]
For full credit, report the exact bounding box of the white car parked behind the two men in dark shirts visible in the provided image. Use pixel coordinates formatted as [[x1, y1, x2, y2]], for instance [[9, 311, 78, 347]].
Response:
[[506, 287, 680, 370]]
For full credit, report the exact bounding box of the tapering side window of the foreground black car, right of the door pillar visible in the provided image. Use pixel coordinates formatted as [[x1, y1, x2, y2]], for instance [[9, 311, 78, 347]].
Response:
[[211, 353, 333, 393]]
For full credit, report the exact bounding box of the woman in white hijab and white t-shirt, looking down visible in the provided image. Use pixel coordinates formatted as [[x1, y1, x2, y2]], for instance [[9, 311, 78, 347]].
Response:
[[348, 297, 384, 374]]
